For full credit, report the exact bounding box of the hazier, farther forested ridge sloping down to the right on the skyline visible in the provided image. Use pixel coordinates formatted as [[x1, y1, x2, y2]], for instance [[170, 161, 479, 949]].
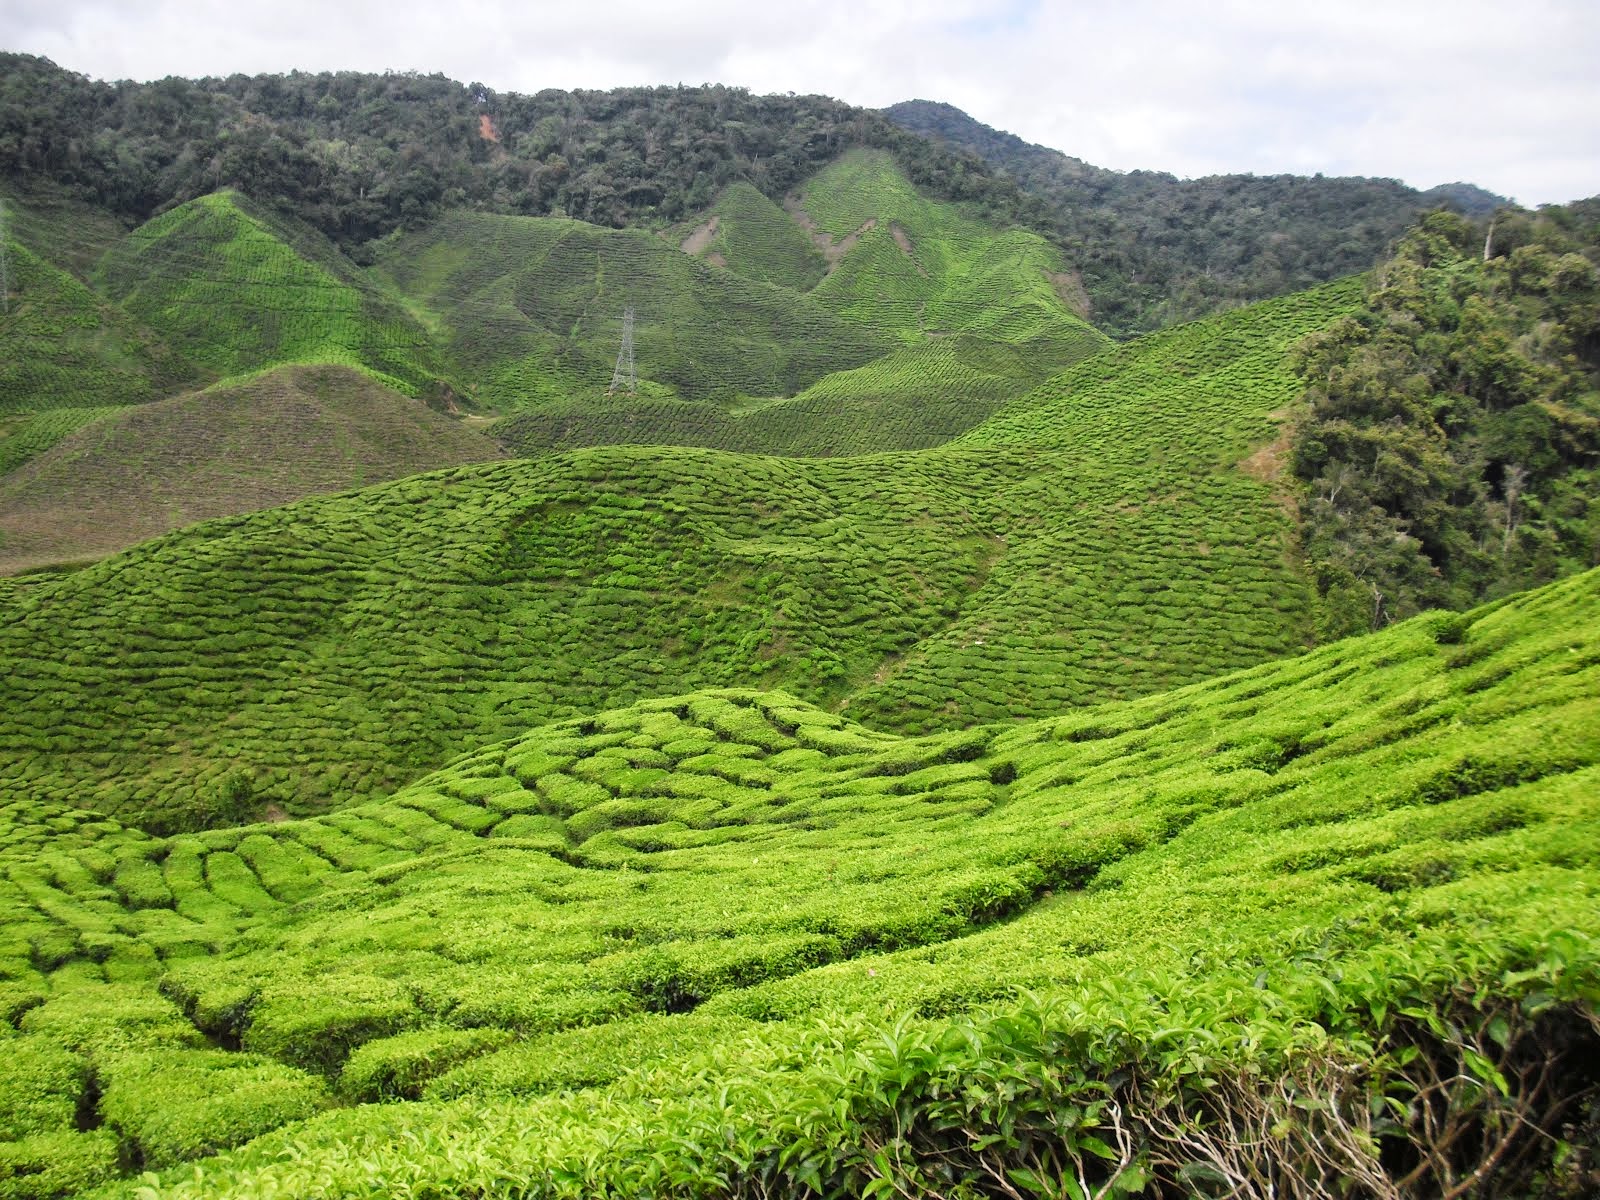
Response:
[[885, 101, 1506, 334]]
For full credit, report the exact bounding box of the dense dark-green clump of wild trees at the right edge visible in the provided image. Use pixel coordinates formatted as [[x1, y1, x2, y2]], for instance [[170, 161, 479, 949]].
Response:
[[1293, 208, 1600, 635]]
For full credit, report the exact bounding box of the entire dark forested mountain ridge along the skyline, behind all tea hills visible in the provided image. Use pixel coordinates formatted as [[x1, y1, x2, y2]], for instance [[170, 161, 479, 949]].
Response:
[[0, 54, 1499, 336]]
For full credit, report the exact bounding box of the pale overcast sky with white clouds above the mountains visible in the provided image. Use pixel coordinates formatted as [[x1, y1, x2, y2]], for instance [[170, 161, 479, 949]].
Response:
[[0, 0, 1600, 205]]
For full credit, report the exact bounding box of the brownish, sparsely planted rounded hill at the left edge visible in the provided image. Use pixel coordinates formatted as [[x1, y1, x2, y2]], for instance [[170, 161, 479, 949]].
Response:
[[0, 366, 502, 574]]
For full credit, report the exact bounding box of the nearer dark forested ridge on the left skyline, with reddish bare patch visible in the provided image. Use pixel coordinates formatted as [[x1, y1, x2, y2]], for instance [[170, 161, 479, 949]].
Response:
[[0, 54, 1027, 259]]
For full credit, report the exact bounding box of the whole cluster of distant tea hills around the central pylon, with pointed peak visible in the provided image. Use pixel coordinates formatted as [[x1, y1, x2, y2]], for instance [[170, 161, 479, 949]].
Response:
[[403, 152, 1107, 454]]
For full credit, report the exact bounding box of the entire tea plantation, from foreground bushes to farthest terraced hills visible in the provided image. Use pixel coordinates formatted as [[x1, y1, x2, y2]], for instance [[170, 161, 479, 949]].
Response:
[[0, 136, 1600, 1200]]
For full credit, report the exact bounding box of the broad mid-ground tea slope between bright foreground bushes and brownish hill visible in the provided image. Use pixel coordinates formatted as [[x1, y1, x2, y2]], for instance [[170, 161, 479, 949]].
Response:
[[0, 276, 1360, 827]]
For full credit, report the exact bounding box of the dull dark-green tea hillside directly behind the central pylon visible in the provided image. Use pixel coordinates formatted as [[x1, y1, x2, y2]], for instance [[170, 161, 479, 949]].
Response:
[[368, 213, 888, 411]]
